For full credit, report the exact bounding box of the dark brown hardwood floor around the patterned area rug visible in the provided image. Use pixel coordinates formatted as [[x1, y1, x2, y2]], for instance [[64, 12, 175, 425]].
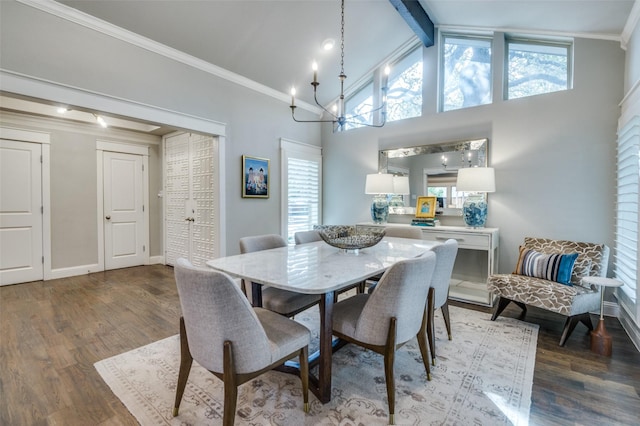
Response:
[[0, 265, 640, 426]]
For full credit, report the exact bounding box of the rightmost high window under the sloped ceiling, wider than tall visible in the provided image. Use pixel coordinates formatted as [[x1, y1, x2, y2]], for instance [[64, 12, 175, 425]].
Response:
[[505, 39, 571, 99]]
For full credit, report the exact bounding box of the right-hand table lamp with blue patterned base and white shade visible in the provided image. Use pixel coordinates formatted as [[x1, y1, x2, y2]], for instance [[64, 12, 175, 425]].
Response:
[[456, 167, 496, 228]]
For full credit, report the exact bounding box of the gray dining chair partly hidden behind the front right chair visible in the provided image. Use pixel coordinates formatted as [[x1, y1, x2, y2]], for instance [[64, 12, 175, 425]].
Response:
[[427, 239, 458, 365]]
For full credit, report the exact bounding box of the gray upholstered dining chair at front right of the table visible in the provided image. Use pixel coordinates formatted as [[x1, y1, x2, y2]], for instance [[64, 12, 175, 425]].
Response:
[[333, 251, 436, 424]]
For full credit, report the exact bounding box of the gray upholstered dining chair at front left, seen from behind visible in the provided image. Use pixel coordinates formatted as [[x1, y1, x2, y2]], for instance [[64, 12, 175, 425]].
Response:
[[173, 258, 310, 426]]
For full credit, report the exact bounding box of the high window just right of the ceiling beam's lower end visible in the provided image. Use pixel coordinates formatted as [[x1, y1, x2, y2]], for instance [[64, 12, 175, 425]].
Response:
[[440, 35, 491, 111]]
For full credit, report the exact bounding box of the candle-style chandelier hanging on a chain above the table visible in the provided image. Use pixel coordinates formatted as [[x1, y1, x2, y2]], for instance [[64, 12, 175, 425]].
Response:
[[290, 0, 389, 131]]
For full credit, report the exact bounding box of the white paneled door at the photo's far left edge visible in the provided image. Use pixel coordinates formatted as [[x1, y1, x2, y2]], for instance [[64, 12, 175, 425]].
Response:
[[0, 140, 44, 285]]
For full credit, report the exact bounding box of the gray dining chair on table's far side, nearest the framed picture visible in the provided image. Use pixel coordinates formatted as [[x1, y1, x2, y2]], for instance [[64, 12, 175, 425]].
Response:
[[240, 234, 320, 317]]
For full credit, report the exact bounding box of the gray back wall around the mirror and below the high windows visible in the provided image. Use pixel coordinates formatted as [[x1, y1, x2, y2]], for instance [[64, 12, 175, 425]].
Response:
[[323, 33, 625, 272]]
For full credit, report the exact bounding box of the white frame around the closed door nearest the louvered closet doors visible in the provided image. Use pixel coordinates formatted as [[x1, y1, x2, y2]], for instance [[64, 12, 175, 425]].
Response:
[[96, 140, 150, 271]]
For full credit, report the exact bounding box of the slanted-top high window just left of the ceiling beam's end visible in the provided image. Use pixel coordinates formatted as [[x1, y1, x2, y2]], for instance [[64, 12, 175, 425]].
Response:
[[387, 45, 422, 121]]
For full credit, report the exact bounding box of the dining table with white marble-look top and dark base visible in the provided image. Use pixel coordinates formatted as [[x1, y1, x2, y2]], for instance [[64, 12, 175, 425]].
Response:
[[206, 236, 440, 403]]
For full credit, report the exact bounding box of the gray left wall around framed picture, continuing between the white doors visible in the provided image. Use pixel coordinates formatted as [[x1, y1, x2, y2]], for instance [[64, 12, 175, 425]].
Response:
[[0, 1, 320, 266]]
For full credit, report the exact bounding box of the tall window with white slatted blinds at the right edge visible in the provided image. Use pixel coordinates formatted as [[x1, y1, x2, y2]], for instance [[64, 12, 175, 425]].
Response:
[[614, 116, 640, 310]]
